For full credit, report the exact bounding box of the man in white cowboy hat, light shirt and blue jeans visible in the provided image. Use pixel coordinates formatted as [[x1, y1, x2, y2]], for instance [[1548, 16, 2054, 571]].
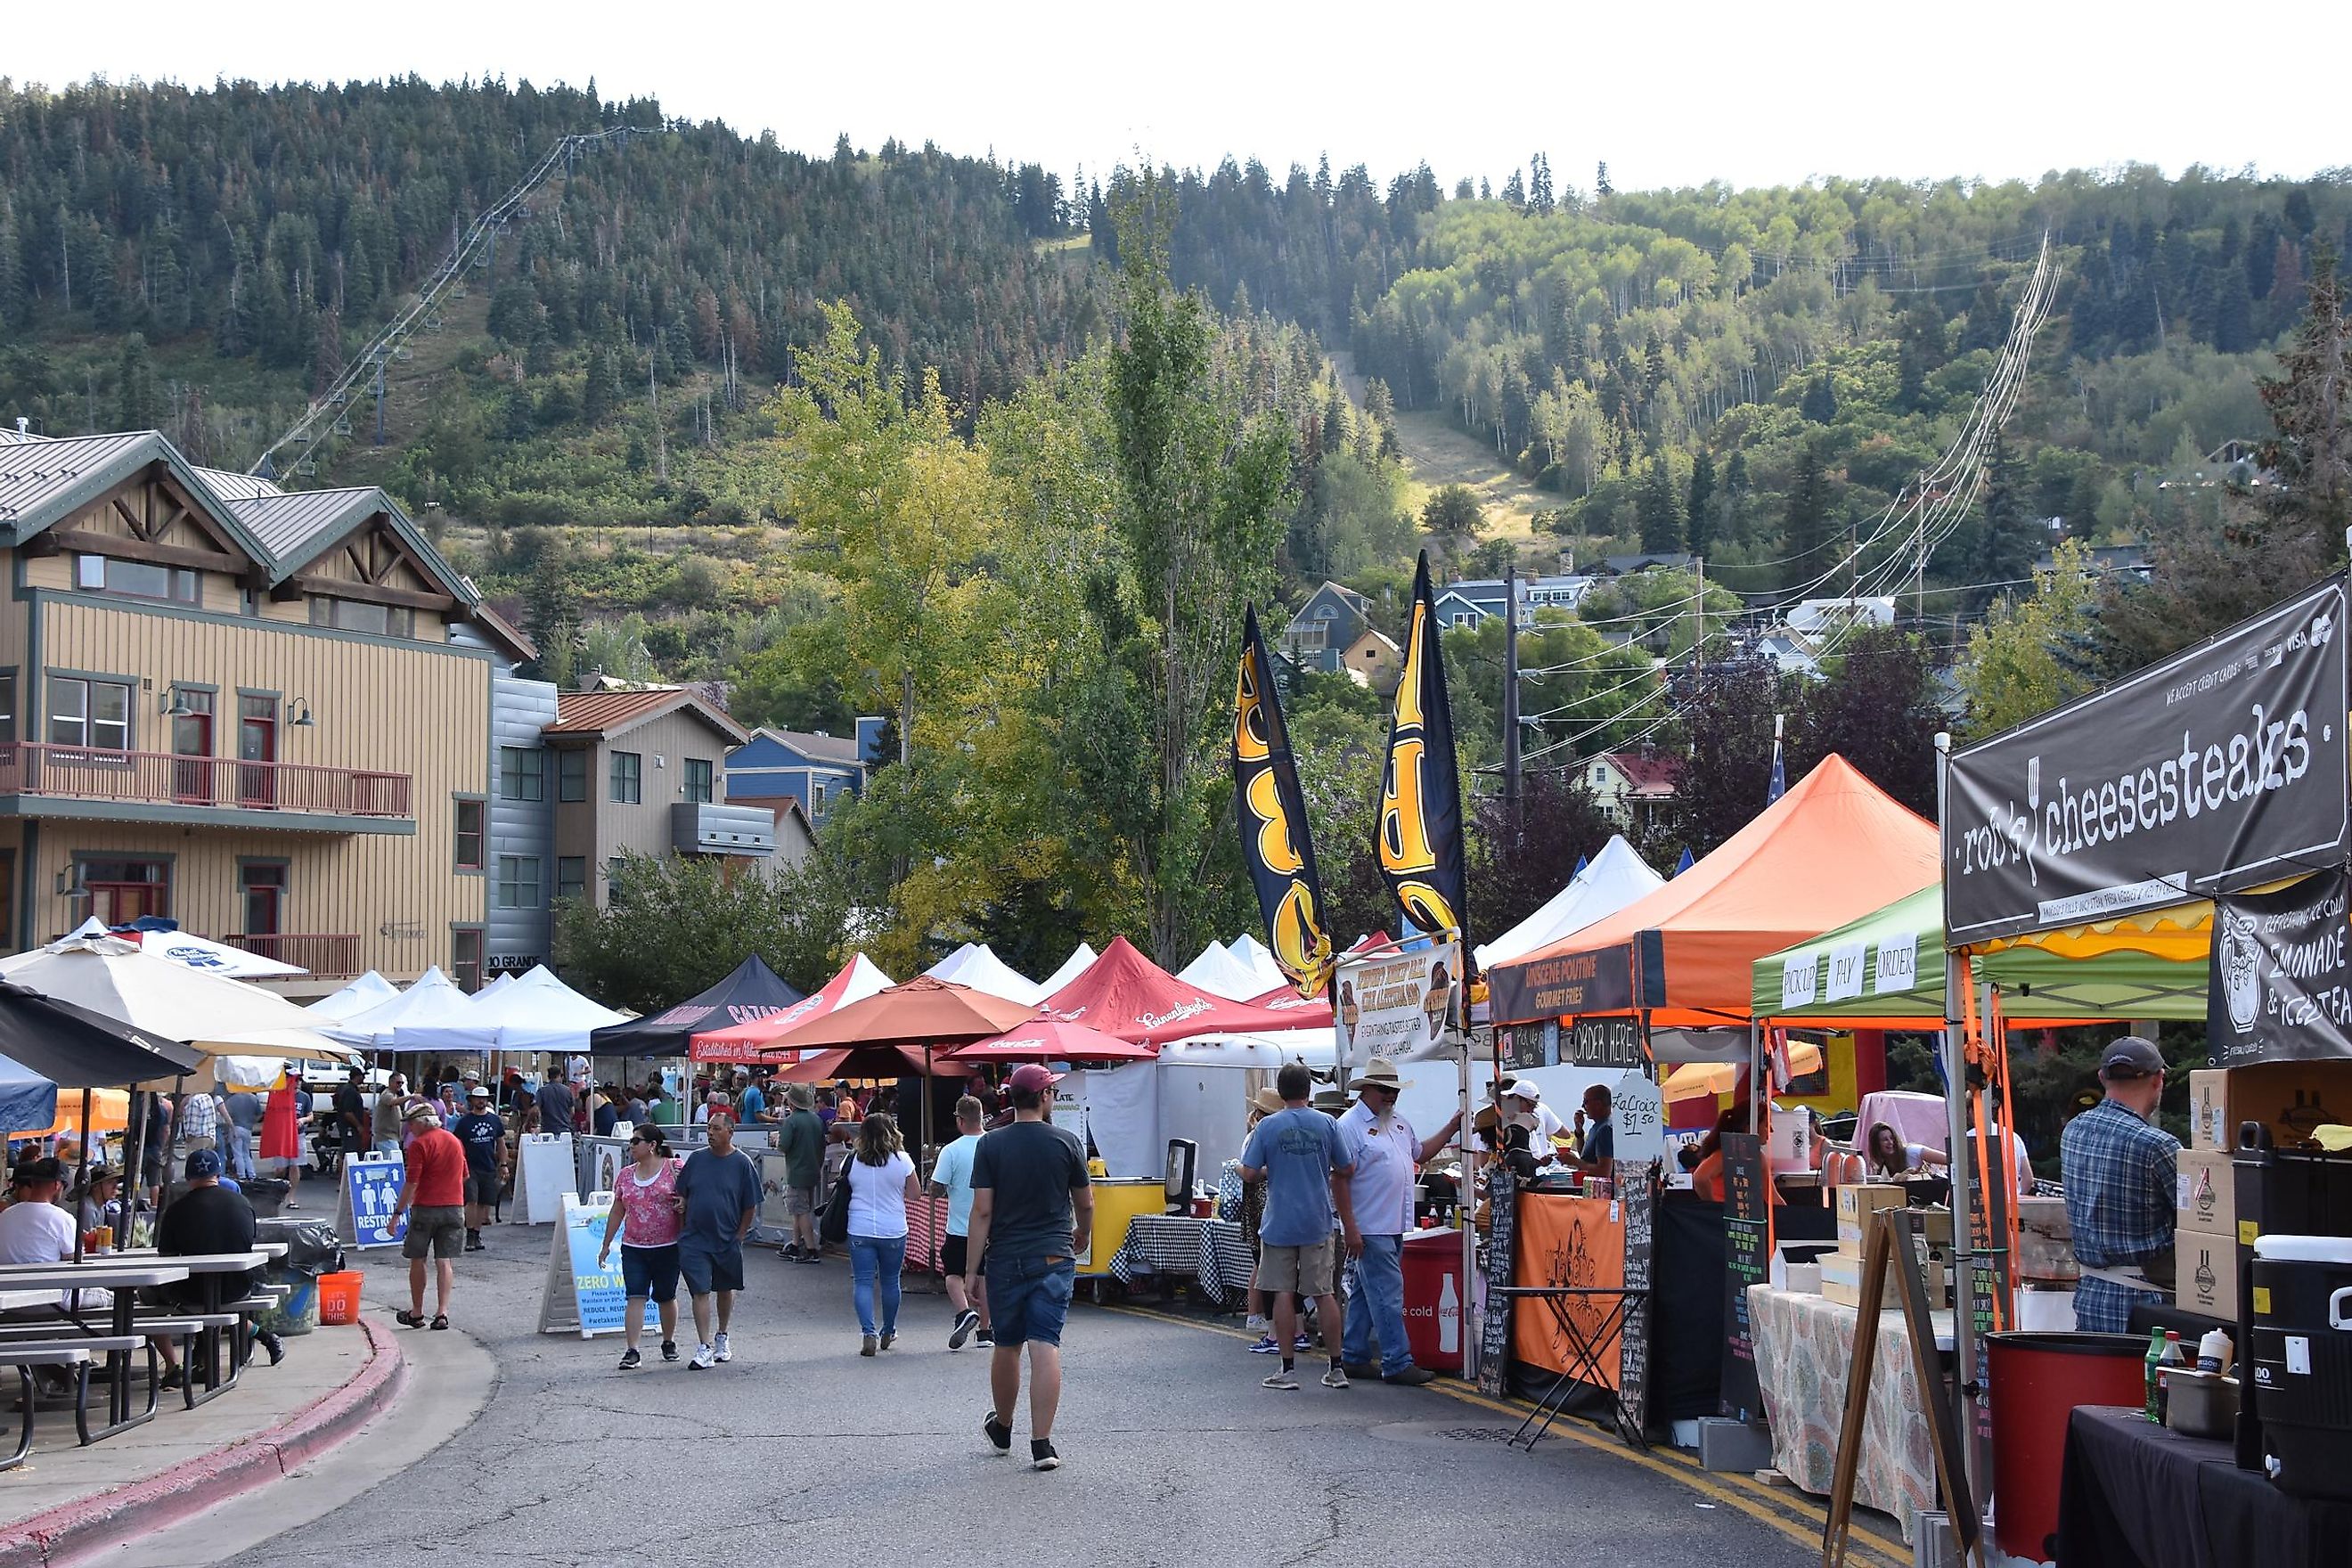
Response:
[[1338, 1056, 1463, 1383]]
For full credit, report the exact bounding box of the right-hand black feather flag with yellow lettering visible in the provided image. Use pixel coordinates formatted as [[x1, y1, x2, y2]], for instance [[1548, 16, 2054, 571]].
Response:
[[1374, 550, 1467, 952]]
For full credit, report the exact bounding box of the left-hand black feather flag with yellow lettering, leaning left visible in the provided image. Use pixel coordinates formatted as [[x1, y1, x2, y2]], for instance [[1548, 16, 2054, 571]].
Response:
[[1232, 608, 1331, 997]]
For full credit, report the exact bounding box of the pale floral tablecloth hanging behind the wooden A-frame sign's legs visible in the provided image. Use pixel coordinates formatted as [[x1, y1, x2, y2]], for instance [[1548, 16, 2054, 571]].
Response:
[[1748, 1286, 1952, 1542]]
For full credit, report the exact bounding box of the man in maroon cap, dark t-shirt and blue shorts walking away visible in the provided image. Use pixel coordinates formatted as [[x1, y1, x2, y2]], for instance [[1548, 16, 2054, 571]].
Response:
[[964, 1063, 1094, 1469]]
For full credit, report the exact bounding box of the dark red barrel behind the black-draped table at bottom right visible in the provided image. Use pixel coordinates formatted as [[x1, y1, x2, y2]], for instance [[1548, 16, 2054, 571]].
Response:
[[1985, 1333, 2147, 1564]]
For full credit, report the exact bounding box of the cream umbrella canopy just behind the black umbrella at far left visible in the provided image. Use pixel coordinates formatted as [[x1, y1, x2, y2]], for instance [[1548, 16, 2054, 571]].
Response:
[[0, 935, 350, 1062]]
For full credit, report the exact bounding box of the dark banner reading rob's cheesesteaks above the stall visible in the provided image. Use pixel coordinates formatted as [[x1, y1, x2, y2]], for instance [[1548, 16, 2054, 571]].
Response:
[[1943, 576, 2348, 947]]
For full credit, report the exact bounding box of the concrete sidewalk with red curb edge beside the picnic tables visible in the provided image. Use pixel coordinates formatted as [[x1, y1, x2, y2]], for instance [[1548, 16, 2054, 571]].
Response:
[[0, 1307, 402, 1568]]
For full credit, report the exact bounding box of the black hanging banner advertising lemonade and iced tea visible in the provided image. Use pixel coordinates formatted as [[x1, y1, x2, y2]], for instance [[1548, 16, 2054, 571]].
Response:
[[2206, 865, 2352, 1067]]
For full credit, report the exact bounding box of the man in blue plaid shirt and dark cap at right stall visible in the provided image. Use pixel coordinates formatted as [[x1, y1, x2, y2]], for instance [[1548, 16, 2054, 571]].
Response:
[[2058, 1034, 2180, 1333]]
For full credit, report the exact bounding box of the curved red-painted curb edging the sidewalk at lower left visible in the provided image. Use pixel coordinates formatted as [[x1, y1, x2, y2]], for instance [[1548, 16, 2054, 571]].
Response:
[[0, 1314, 407, 1568]]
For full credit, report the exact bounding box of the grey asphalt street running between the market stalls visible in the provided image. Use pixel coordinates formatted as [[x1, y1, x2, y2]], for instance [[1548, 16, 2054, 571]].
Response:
[[166, 1227, 1853, 1568]]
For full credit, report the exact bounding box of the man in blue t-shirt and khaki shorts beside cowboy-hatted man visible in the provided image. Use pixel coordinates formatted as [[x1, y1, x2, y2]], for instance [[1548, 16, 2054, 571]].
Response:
[[1242, 1063, 1362, 1392]]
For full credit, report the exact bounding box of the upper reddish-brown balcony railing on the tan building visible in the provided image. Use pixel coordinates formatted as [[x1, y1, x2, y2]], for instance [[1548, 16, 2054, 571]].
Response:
[[0, 740, 409, 818]]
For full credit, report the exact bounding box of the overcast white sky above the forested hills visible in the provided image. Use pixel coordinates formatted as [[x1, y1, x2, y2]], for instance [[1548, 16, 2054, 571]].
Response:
[[0, 0, 2352, 188]]
